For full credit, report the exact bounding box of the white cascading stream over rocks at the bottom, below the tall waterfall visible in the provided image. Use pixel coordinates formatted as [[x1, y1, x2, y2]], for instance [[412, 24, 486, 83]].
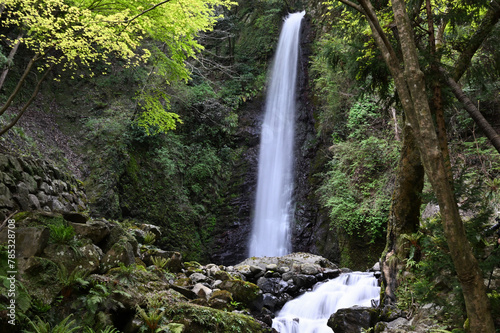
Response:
[[273, 272, 380, 333]]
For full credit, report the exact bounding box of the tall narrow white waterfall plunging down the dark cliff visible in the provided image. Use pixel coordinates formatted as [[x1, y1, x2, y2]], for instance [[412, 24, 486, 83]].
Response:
[[249, 12, 305, 257]]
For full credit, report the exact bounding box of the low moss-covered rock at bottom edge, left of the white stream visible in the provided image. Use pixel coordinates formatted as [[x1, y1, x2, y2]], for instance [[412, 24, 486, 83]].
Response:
[[165, 303, 270, 333]]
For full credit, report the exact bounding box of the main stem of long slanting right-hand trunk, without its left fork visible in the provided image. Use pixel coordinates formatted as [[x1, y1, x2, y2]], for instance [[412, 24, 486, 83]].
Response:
[[392, 0, 495, 333]]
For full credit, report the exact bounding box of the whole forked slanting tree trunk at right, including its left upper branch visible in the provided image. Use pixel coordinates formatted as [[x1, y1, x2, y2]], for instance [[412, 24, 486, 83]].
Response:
[[340, 0, 495, 333]]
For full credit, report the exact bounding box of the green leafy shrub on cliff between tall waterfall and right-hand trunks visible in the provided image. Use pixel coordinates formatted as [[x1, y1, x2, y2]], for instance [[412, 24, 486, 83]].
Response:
[[319, 132, 397, 242]]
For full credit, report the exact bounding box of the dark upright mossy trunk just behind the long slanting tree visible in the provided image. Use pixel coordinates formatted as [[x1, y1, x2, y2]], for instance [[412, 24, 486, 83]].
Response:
[[382, 126, 424, 304]]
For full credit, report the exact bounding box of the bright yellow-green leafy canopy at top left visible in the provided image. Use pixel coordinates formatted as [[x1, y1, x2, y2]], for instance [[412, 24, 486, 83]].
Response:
[[0, 0, 236, 133]]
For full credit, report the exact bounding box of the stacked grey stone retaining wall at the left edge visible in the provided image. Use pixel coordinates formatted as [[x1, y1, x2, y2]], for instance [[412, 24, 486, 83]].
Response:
[[0, 154, 87, 221]]
